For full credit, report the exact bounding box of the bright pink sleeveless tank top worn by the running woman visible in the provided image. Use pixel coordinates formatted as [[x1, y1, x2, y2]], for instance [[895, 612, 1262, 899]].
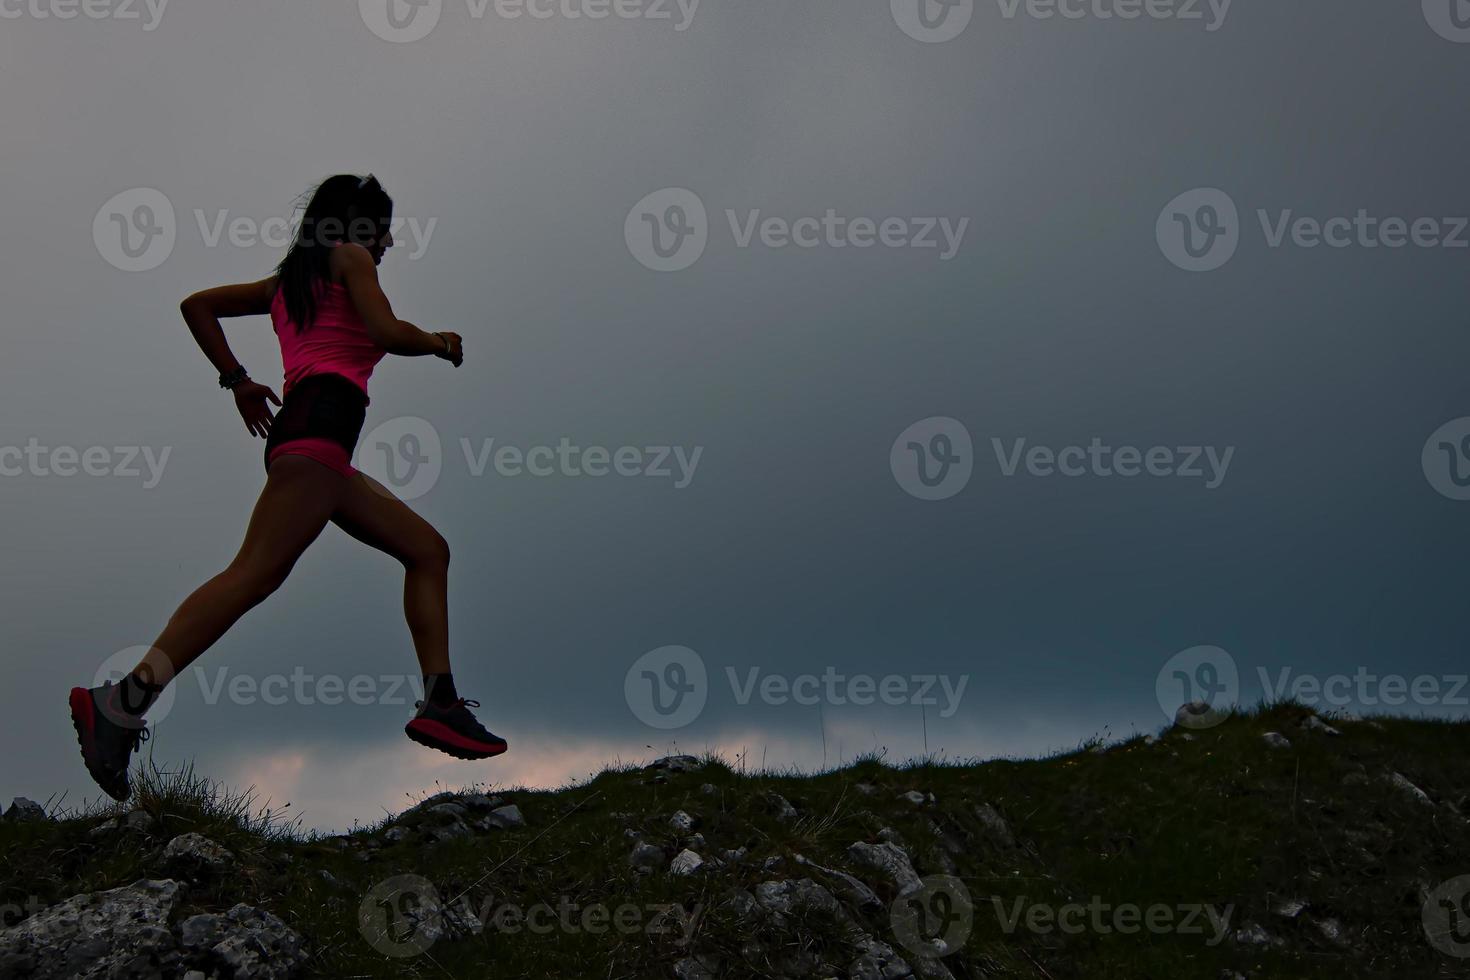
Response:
[[270, 274, 387, 398]]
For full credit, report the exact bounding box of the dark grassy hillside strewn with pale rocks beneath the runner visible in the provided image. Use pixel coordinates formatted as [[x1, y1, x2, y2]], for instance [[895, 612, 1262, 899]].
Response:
[[0, 705, 1470, 980]]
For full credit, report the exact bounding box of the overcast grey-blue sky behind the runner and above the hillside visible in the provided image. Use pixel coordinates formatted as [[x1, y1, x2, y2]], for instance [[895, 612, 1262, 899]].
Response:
[[0, 0, 1470, 829]]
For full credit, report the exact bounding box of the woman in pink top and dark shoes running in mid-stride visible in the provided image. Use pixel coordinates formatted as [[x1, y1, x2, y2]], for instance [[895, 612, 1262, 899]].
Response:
[[71, 175, 506, 801]]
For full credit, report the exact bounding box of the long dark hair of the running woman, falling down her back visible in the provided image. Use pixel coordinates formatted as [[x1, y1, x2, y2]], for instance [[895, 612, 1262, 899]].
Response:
[[276, 173, 392, 331]]
